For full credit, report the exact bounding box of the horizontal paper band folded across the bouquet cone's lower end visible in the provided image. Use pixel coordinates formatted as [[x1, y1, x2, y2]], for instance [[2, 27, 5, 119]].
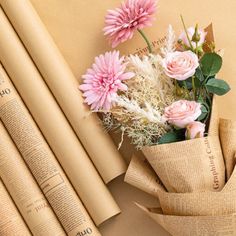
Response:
[[158, 190, 236, 216]]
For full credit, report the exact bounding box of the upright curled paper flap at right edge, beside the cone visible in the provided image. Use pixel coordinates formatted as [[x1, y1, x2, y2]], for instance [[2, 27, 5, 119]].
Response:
[[220, 119, 236, 179]]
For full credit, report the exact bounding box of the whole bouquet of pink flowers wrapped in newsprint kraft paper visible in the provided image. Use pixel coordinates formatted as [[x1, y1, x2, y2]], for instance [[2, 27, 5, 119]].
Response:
[[80, 0, 236, 236]]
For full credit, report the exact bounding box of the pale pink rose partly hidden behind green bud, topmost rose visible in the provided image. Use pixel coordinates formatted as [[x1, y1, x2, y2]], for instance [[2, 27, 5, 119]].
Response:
[[179, 27, 207, 49]]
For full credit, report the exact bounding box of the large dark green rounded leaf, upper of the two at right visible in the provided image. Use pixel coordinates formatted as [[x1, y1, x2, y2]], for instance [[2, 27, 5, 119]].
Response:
[[200, 53, 222, 76]]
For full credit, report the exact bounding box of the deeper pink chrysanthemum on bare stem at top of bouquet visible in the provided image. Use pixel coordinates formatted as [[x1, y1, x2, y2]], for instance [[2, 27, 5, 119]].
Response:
[[103, 0, 157, 48]]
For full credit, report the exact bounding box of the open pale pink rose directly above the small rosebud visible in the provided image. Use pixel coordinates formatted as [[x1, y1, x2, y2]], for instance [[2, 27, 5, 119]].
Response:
[[164, 100, 202, 128]]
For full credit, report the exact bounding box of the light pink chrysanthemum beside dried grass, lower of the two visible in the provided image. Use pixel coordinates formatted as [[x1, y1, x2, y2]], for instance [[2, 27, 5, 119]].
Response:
[[79, 51, 134, 111]]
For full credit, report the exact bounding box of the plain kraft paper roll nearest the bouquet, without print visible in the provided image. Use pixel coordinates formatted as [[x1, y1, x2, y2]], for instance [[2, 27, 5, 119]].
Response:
[[0, 0, 126, 183]]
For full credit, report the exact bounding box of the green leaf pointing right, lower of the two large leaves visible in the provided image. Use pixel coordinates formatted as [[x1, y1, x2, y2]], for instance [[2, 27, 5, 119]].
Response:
[[206, 78, 230, 96]]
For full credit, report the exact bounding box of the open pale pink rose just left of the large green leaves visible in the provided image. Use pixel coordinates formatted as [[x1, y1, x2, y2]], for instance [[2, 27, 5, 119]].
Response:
[[162, 51, 199, 80]]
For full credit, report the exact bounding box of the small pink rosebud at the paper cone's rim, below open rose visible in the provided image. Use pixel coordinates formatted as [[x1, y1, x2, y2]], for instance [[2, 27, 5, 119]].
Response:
[[185, 121, 206, 139]]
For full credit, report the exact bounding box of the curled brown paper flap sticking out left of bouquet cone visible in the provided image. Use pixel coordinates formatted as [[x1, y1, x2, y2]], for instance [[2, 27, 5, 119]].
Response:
[[125, 156, 165, 197]]
